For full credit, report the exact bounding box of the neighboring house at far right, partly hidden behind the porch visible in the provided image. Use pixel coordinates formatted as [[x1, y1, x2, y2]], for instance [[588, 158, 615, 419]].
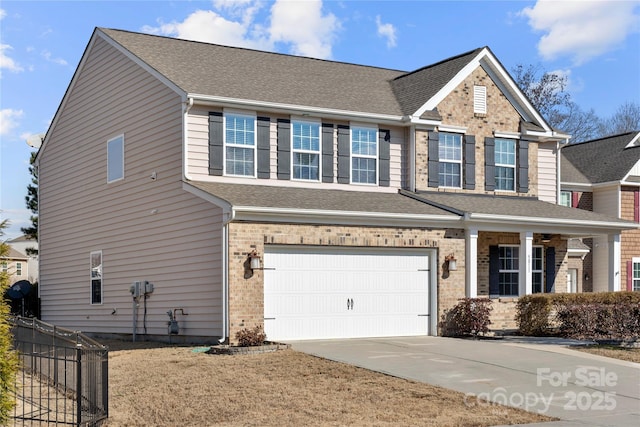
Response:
[[561, 131, 640, 291]]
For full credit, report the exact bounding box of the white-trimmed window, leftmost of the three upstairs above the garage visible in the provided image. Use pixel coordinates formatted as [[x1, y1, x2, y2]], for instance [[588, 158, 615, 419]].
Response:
[[224, 113, 256, 177]]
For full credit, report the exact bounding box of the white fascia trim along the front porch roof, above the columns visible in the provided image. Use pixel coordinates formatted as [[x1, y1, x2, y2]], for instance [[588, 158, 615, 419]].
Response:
[[466, 213, 640, 233]]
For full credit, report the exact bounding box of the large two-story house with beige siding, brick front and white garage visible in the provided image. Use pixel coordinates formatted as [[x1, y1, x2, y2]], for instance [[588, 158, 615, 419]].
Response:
[[37, 28, 637, 341]]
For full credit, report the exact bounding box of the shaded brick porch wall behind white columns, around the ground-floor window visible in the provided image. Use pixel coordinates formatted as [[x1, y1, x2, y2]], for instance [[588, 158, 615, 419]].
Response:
[[478, 231, 568, 330]]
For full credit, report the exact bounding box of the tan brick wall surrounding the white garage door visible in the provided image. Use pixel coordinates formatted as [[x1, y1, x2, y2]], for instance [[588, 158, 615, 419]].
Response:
[[229, 222, 465, 343]]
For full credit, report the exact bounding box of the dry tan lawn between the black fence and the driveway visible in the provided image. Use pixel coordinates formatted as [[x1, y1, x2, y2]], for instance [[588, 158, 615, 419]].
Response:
[[106, 342, 550, 427]]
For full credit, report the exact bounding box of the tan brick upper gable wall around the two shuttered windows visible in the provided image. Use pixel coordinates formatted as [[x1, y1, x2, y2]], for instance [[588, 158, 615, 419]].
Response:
[[416, 67, 538, 196]]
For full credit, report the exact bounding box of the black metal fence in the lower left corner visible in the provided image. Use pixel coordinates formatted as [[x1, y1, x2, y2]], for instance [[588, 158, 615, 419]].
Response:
[[10, 317, 109, 426]]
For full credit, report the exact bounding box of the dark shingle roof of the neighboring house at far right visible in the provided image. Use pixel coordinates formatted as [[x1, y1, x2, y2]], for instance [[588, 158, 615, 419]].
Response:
[[560, 131, 640, 184]]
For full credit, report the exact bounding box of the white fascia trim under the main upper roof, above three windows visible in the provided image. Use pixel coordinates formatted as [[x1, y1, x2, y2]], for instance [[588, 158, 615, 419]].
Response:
[[189, 93, 406, 125]]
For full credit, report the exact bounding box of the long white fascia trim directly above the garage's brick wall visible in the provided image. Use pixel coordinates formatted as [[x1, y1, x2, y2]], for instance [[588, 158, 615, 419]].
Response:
[[233, 206, 462, 228]]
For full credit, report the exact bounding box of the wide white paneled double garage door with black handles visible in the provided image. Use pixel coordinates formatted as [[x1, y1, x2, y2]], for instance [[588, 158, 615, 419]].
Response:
[[264, 246, 430, 340]]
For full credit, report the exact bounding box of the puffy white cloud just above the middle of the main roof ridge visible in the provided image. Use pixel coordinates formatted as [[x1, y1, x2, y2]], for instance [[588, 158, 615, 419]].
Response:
[[269, 0, 340, 59]]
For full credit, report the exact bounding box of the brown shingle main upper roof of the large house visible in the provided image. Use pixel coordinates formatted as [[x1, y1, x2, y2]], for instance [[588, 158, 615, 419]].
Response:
[[99, 28, 480, 117]]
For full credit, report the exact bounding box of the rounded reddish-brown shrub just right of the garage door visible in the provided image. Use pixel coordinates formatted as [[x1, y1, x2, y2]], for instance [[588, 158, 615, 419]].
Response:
[[444, 298, 493, 337]]
